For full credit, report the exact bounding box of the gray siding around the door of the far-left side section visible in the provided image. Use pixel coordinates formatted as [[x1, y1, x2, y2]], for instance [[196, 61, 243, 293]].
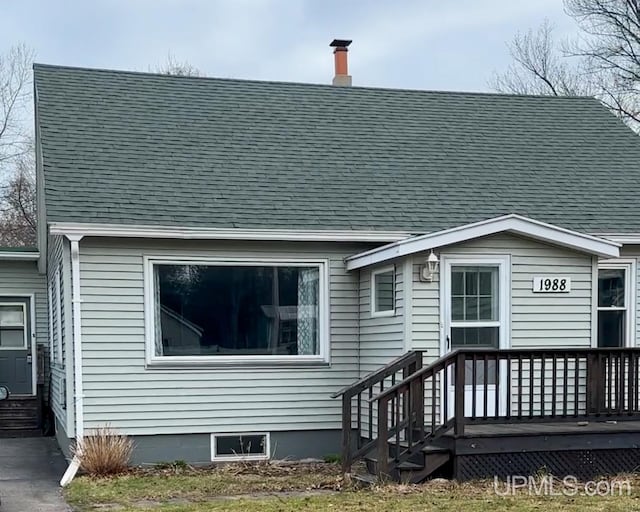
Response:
[[0, 261, 49, 388]]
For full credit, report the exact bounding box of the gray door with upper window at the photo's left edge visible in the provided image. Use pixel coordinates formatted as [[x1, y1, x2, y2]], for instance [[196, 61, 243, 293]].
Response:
[[0, 298, 33, 395]]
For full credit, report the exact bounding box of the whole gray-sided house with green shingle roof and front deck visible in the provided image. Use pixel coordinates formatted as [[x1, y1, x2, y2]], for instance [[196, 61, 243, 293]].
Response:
[[0, 41, 640, 480]]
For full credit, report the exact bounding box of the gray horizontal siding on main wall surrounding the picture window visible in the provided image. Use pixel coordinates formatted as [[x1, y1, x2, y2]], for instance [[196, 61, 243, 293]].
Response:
[[80, 238, 369, 435]]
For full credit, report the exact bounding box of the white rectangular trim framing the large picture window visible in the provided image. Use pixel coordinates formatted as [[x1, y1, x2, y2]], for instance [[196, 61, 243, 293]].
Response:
[[143, 255, 330, 368]]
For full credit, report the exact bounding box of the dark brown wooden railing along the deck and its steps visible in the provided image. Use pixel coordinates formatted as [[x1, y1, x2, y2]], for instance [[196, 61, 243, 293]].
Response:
[[335, 348, 640, 474]]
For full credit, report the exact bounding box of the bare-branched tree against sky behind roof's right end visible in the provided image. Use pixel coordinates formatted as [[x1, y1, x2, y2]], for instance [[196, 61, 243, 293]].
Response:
[[491, 0, 640, 133]]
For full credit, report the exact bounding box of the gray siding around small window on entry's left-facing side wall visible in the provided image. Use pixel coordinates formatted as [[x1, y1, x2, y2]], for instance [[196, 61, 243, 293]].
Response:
[[359, 263, 405, 377]]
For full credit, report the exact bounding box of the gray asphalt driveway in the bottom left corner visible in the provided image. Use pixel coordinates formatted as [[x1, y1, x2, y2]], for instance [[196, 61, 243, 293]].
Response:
[[0, 437, 71, 512]]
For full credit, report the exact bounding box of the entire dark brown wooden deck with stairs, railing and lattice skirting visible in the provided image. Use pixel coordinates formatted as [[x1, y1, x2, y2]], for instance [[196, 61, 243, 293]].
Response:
[[332, 347, 640, 483]]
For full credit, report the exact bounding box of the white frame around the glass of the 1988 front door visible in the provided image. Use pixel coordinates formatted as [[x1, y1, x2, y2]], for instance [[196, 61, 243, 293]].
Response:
[[440, 254, 511, 355]]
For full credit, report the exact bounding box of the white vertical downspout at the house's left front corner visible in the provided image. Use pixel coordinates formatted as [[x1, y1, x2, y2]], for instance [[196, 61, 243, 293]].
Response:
[[60, 235, 84, 487]]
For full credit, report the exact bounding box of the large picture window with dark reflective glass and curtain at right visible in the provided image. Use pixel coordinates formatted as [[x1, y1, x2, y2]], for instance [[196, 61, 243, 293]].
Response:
[[144, 261, 326, 360]]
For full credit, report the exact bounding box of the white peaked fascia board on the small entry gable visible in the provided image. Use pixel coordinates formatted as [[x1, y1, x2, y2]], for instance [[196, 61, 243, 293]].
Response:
[[345, 214, 620, 270]]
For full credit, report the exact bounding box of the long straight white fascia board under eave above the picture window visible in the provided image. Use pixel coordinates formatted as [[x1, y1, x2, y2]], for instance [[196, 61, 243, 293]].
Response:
[[49, 223, 411, 243]]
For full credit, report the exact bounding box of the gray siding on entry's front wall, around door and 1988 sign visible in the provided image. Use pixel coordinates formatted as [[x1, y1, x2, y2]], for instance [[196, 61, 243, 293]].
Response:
[[412, 234, 593, 359]]
